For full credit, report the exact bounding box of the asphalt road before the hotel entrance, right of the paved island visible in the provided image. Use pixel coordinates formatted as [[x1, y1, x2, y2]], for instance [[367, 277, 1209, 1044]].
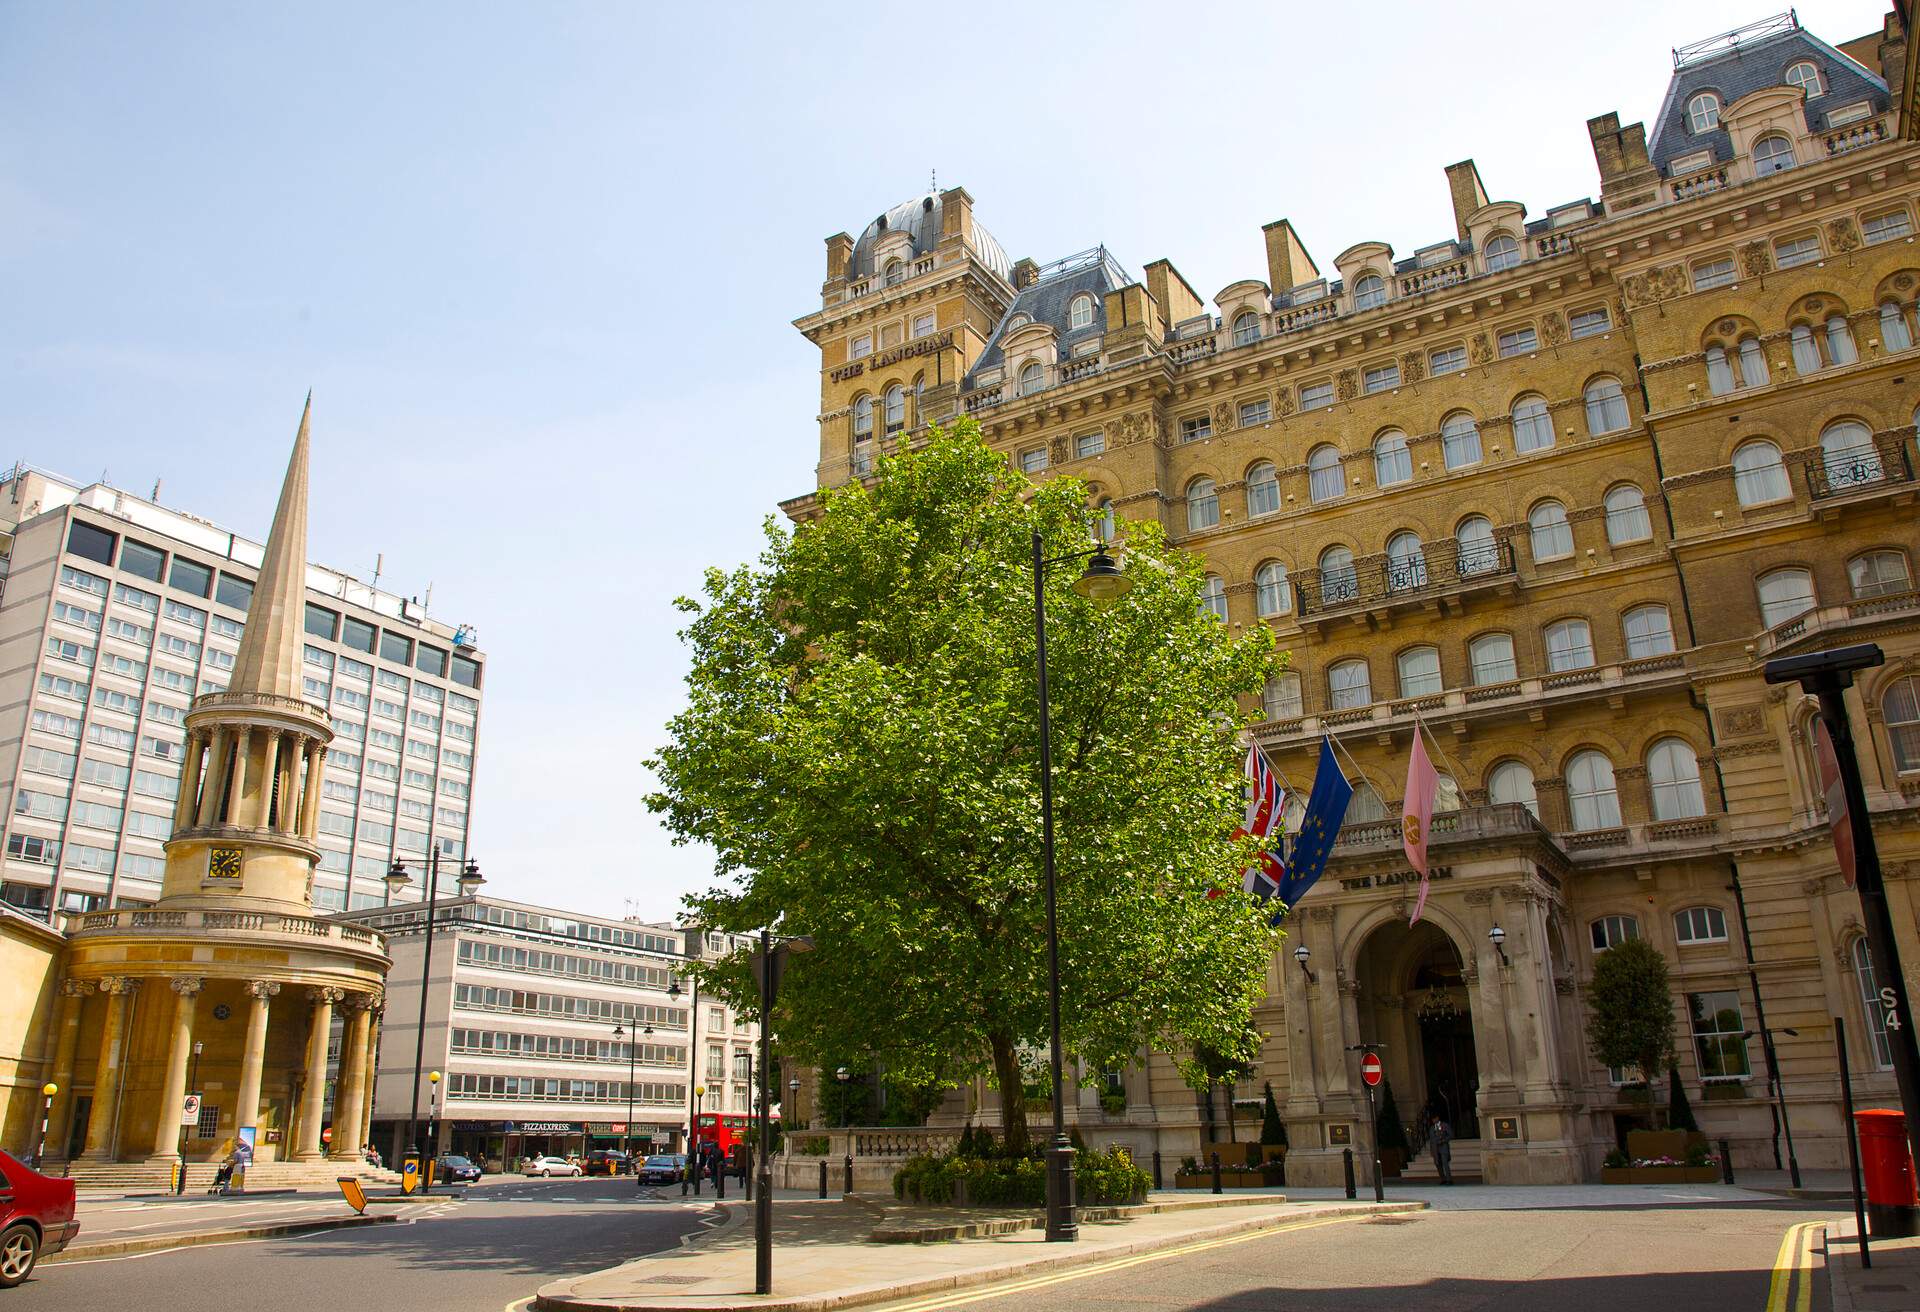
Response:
[[867, 1204, 1836, 1312]]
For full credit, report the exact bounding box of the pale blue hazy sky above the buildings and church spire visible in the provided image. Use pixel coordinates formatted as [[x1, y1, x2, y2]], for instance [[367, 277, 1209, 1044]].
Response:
[[0, 0, 1887, 916]]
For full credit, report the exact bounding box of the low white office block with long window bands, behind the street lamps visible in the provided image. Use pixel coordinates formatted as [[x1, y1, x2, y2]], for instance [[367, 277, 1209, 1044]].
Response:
[[344, 891, 760, 1170]]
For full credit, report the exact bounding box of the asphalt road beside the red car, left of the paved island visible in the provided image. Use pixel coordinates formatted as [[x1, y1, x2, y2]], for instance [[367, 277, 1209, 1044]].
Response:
[[15, 1179, 710, 1312]]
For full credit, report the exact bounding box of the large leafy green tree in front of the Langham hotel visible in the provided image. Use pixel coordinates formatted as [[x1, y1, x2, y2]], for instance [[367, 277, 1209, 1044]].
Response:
[[647, 421, 1281, 1145]]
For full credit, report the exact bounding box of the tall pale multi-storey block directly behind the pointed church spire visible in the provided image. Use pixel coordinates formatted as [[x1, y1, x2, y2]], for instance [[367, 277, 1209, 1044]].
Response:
[[0, 465, 486, 920]]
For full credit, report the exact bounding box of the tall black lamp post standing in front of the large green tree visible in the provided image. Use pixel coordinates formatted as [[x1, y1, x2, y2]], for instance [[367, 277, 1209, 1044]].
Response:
[[1033, 528, 1133, 1243]]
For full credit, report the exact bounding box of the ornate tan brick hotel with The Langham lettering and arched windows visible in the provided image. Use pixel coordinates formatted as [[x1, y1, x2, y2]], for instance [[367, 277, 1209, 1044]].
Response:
[[785, 15, 1920, 1183]]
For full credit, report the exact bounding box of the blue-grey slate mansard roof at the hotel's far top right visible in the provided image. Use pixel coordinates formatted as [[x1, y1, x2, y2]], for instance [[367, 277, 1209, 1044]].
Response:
[[1647, 27, 1887, 175]]
